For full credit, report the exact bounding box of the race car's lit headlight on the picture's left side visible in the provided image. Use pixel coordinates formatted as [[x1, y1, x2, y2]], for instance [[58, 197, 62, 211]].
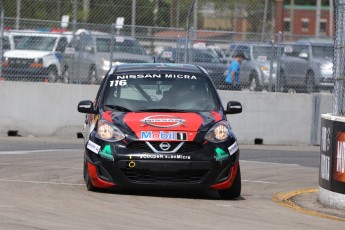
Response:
[[97, 120, 125, 141]]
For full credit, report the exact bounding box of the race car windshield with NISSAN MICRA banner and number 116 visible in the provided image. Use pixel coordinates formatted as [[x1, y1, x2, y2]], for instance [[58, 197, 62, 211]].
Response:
[[101, 72, 219, 112]]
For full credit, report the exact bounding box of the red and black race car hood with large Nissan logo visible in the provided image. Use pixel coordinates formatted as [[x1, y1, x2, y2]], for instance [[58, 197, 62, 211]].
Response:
[[102, 111, 224, 141]]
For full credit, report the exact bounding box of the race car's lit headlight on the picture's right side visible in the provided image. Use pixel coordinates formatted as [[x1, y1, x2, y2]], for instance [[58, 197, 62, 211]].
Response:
[[205, 121, 230, 143]]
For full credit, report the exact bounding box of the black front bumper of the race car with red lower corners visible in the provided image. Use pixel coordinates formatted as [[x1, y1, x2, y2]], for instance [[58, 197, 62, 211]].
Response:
[[85, 138, 239, 189]]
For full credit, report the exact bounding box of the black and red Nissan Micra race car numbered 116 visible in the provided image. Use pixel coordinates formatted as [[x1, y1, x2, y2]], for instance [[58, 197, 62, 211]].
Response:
[[78, 63, 242, 199]]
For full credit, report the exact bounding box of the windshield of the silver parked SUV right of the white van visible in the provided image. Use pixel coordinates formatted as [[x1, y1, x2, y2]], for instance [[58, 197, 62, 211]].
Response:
[[96, 37, 146, 55]]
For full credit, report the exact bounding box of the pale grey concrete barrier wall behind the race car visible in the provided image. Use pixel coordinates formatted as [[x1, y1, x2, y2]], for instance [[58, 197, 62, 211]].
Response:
[[0, 81, 332, 145]]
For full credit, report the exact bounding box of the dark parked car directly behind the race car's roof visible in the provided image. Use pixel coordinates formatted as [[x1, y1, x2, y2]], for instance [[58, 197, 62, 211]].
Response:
[[157, 47, 228, 89]]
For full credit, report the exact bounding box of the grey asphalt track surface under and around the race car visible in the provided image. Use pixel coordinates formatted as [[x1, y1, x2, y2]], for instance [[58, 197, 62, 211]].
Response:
[[0, 137, 345, 230]]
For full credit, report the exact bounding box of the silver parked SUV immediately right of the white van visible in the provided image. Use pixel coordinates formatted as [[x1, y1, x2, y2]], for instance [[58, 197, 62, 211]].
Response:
[[63, 29, 153, 84]]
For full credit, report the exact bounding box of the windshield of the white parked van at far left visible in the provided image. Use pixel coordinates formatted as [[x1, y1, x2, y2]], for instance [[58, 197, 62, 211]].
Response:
[[14, 36, 57, 51]]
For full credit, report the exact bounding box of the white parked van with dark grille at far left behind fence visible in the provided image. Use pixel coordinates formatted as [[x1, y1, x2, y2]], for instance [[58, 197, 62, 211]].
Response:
[[2, 31, 69, 82]]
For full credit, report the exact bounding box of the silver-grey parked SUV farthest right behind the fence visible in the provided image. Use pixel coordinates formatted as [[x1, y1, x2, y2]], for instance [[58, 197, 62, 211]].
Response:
[[280, 39, 334, 93]]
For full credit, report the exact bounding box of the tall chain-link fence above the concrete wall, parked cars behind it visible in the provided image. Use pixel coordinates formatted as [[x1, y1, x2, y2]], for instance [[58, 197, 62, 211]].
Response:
[[0, 0, 334, 93]]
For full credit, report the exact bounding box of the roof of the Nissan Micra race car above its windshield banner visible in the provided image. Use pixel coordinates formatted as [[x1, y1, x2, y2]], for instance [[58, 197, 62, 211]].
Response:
[[110, 63, 202, 74]]
